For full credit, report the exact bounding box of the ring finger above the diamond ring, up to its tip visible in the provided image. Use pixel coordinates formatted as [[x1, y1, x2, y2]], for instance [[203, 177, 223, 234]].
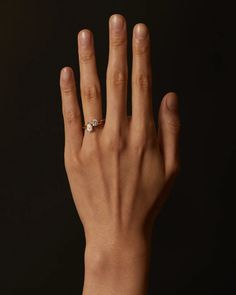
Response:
[[78, 29, 102, 123]]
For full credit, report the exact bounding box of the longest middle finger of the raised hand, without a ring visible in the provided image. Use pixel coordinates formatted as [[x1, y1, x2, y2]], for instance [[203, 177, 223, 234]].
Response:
[[105, 14, 128, 130]]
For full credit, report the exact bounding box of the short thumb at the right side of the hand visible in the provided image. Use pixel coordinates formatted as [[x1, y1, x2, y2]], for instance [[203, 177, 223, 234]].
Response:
[[158, 92, 180, 177]]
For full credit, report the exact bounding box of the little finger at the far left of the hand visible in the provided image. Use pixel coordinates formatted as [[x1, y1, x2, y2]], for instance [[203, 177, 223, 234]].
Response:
[[60, 67, 83, 154]]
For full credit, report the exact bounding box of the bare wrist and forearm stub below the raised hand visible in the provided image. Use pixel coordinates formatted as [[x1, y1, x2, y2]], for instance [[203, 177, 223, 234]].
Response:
[[83, 236, 150, 295]]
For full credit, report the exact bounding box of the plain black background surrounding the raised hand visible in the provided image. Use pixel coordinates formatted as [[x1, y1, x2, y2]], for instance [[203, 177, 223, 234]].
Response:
[[0, 0, 236, 295]]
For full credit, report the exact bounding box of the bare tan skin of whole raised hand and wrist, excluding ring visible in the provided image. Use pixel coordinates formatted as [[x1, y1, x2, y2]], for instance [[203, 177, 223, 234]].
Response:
[[60, 14, 180, 295]]
